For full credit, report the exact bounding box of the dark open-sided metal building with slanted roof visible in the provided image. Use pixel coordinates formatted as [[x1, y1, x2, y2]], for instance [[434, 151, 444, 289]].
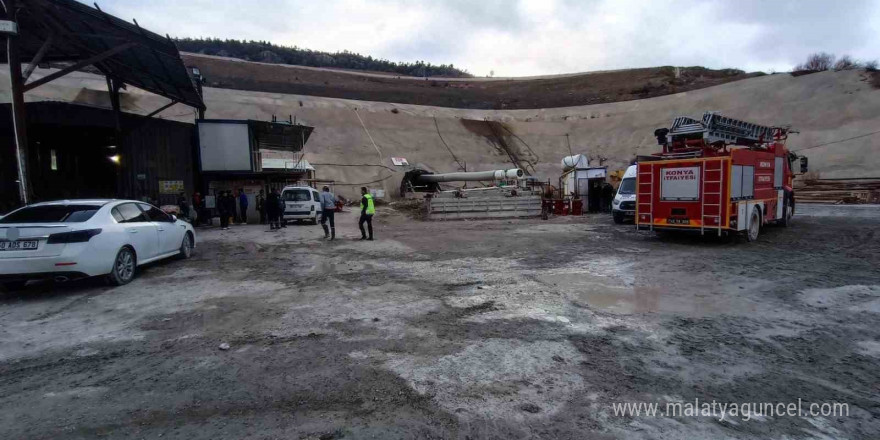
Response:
[[0, 0, 205, 211]]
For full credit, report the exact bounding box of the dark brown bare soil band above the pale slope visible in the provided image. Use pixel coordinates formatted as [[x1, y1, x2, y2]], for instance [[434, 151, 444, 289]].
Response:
[[182, 53, 760, 109]]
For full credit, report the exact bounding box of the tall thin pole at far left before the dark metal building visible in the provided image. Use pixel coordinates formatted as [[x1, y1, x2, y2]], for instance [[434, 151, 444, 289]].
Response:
[[0, 0, 31, 206]]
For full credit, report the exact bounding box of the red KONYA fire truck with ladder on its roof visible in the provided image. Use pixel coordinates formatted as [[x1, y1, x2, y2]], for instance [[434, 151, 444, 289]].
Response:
[[635, 112, 807, 241]]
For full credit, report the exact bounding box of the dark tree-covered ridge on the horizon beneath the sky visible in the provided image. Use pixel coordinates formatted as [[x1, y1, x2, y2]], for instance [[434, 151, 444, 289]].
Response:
[[175, 38, 472, 78]]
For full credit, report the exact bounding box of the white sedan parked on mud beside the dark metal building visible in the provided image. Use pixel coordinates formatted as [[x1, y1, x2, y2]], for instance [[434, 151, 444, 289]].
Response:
[[0, 200, 195, 289]]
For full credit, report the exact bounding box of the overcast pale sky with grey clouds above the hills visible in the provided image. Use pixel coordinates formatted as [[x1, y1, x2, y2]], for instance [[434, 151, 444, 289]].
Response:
[[96, 0, 880, 76]]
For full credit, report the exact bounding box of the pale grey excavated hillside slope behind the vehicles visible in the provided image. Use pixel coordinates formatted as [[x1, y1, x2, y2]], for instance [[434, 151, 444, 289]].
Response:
[[6, 62, 880, 196]]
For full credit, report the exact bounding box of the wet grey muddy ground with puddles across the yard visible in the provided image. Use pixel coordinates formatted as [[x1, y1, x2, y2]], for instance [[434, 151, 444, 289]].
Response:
[[0, 207, 880, 439]]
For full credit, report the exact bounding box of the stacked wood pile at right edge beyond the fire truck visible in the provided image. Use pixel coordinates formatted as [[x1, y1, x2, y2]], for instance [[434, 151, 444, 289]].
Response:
[[795, 179, 880, 205]]
